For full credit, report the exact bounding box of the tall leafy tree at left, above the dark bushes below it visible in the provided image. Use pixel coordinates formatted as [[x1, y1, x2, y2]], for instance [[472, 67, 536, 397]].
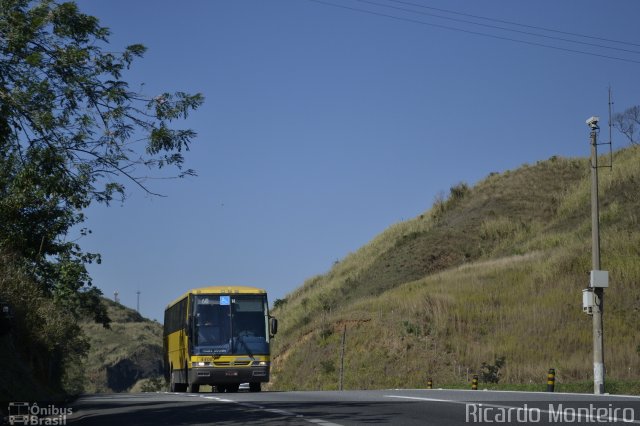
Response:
[[0, 0, 204, 325]]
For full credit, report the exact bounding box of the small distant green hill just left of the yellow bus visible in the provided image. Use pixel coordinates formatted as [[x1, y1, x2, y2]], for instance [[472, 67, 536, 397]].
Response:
[[81, 299, 164, 393]]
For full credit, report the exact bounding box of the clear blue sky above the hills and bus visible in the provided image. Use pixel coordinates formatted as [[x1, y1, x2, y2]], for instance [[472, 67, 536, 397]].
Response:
[[72, 0, 640, 321]]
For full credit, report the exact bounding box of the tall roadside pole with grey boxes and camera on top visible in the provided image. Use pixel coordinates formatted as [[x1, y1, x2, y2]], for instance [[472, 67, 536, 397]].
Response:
[[587, 117, 609, 395]]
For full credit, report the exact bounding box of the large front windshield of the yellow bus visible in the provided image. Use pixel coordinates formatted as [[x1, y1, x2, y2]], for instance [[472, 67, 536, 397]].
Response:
[[193, 294, 269, 357]]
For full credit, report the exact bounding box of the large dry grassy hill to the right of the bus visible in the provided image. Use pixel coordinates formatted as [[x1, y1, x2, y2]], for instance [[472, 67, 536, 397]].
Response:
[[271, 146, 640, 392]]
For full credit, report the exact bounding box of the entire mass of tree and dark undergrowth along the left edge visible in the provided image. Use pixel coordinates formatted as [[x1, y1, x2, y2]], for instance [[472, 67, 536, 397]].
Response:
[[0, 0, 204, 406]]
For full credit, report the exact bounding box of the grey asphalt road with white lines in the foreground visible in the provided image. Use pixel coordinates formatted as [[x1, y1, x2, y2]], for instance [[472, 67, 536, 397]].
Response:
[[67, 389, 640, 426]]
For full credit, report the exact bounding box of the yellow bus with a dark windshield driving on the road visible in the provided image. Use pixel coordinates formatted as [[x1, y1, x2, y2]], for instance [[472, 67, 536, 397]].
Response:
[[163, 286, 278, 392]]
